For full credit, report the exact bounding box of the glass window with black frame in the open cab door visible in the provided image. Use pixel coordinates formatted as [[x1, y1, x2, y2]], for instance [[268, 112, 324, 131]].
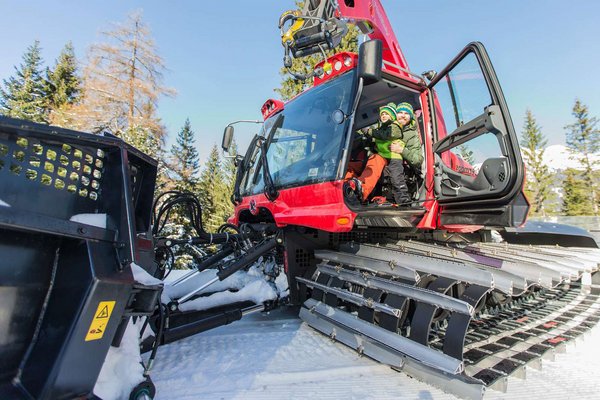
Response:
[[429, 43, 522, 203]]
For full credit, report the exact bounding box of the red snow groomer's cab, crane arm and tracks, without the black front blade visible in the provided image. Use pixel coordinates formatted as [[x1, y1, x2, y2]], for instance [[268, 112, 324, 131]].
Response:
[[218, 0, 600, 398]]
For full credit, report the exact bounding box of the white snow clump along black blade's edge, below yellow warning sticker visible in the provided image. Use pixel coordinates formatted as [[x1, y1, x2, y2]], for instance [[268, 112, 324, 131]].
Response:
[[94, 321, 144, 400]]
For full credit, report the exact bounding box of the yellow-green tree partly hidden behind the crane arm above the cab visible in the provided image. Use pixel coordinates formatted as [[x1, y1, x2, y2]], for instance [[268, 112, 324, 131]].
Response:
[[275, 1, 360, 101]]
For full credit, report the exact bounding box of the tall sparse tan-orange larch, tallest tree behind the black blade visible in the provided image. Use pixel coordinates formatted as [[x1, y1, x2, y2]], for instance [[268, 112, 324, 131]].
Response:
[[76, 13, 175, 157]]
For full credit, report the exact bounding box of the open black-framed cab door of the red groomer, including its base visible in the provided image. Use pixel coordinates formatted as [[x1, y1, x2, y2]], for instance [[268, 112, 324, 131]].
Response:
[[429, 43, 529, 228]]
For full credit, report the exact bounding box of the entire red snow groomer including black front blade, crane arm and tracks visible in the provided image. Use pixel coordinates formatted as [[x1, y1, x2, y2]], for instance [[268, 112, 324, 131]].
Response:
[[0, 0, 600, 399]]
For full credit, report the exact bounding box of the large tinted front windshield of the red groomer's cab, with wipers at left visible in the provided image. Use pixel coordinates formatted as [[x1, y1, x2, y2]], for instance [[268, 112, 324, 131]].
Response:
[[243, 71, 355, 195]]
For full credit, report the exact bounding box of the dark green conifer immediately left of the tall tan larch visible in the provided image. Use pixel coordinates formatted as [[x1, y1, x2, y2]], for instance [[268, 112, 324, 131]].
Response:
[[46, 42, 82, 128]]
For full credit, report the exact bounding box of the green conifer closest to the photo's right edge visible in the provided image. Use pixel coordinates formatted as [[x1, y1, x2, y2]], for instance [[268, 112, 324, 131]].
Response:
[[565, 99, 600, 216]]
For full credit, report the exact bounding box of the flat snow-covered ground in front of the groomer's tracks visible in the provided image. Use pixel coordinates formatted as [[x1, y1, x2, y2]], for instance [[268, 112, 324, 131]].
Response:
[[146, 309, 600, 400]]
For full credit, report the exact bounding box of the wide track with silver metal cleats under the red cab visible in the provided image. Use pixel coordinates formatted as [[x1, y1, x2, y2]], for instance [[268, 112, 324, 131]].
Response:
[[297, 241, 600, 399]]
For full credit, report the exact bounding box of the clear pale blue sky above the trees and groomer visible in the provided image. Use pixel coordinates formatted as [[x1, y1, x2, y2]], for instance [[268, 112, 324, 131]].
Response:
[[0, 0, 600, 162]]
